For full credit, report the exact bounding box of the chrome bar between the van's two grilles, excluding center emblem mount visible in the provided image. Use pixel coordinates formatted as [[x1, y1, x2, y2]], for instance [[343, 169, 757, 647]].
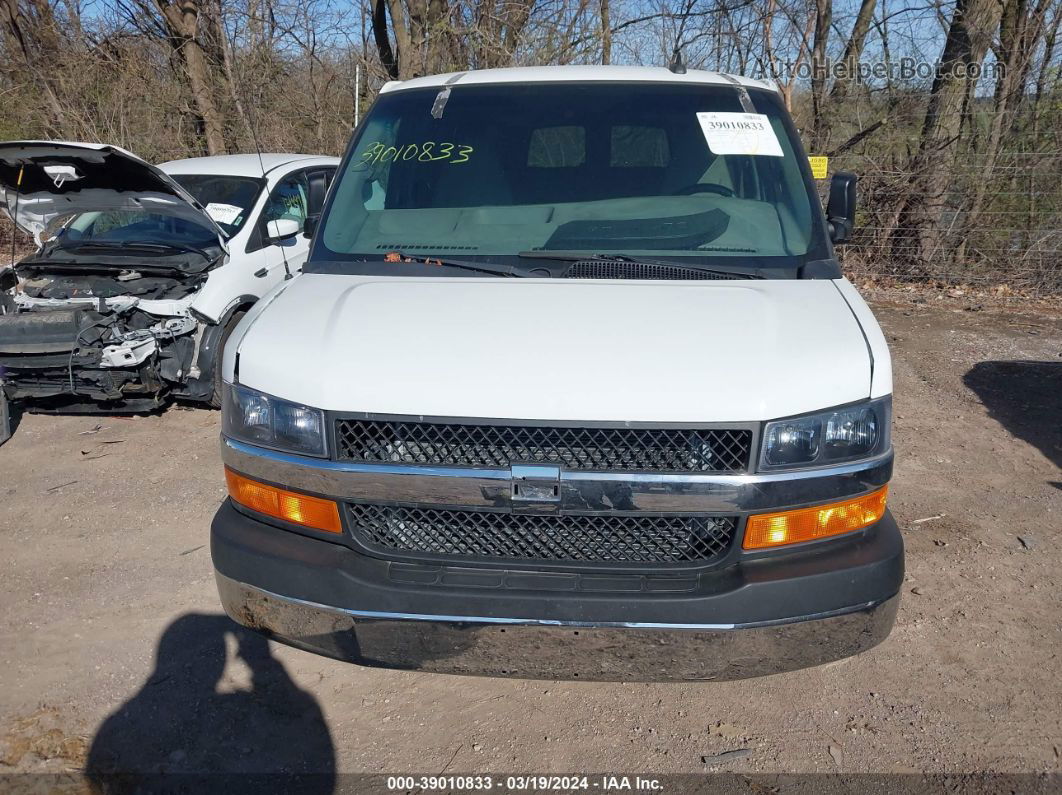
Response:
[[221, 437, 892, 513]]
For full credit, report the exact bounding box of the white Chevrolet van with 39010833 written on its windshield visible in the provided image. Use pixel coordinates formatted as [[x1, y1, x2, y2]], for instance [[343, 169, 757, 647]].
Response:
[[211, 67, 904, 679]]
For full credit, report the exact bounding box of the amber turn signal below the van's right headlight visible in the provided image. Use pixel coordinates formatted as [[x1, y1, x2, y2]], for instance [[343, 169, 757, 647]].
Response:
[[741, 486, 889, 550]]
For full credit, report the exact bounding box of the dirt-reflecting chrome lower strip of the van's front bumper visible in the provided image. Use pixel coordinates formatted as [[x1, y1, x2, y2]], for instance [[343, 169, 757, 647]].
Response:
[[216, 572, 900, 681]]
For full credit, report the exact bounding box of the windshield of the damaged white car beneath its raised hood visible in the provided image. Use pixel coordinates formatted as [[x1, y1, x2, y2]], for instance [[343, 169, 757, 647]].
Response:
[[41, 209, 218, 252]]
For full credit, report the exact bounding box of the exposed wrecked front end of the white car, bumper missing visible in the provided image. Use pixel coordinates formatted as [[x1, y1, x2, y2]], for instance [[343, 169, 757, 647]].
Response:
[[0, 268, 211, 411]]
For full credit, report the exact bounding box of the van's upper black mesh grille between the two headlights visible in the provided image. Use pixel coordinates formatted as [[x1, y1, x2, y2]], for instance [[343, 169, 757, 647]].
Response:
[[336, 419, 752, 472]]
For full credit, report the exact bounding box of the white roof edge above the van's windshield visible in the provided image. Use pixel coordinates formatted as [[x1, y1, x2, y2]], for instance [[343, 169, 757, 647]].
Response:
[[380, 66, 775, 93]]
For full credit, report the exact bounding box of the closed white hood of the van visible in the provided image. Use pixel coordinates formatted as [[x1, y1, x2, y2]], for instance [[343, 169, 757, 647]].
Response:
[[236, 274, 871, 422]]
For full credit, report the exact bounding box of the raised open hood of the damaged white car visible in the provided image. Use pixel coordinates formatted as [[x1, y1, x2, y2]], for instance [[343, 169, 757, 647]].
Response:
[[0, 141, 225, 248]]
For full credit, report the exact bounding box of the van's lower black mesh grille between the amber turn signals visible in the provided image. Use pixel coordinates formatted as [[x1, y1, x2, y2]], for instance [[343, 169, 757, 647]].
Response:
[[347, 503, 737, 564]]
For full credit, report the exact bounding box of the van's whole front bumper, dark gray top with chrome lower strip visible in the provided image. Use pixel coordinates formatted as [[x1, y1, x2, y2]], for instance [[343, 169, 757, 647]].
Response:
[[211, 502, 904, 681]]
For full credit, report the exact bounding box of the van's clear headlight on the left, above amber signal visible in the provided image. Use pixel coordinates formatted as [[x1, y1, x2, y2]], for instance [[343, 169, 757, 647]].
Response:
[[221, 384, 328, 456]]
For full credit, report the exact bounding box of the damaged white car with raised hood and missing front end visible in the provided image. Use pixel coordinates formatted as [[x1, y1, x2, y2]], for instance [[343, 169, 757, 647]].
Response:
[[0, 141, 339, 428]]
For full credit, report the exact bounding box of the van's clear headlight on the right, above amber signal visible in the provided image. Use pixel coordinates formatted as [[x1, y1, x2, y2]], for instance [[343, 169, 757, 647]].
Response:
[[759, 397, 892, 469]]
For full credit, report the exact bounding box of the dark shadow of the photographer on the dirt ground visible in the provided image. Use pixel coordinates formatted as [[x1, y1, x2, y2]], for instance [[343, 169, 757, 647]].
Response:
[[85, 613, 336, 793]]
